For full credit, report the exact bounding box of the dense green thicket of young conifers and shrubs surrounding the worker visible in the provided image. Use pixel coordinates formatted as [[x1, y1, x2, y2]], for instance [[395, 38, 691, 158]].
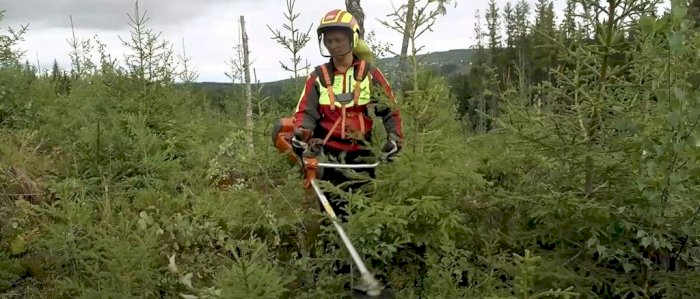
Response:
[[0, 0, 700, 299]]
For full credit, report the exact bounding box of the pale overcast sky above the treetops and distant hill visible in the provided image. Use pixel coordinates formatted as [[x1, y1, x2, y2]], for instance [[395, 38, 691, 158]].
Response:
[[0, 0, 565, 82]]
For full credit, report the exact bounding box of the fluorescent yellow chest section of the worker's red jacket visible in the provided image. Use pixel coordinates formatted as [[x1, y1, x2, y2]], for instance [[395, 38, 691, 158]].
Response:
[[316, 68, 372, 108]]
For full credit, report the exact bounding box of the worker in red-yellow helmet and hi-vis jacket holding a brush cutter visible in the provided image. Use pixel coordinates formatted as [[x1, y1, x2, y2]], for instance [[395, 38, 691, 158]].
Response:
[[292, 9, 403, 217]]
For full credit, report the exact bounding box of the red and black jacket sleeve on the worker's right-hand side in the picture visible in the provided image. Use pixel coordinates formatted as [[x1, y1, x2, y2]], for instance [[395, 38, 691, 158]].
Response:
[[370, 66, 403, 142]]
